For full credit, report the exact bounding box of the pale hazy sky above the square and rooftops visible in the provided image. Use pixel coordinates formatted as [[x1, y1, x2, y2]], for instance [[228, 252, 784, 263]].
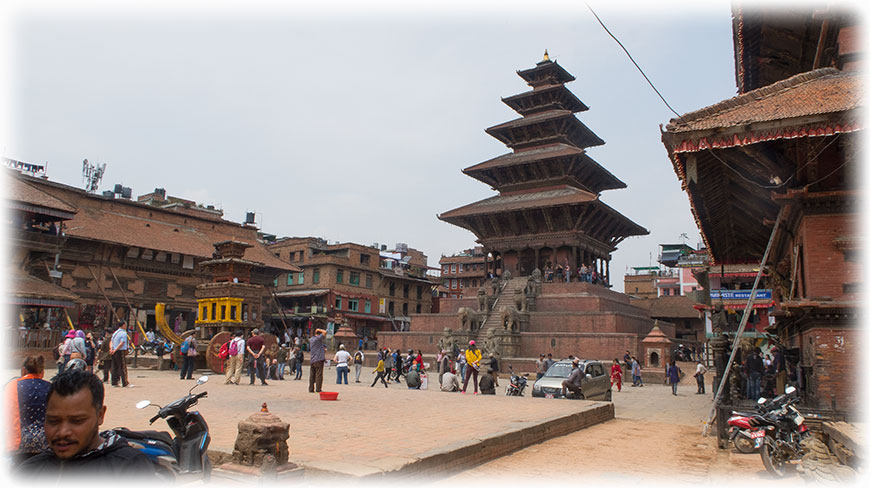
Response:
[[0, 1, 784, 291]]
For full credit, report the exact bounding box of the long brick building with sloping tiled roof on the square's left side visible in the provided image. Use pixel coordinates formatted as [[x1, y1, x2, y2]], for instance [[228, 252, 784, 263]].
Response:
[[5, 171, 298, 362]]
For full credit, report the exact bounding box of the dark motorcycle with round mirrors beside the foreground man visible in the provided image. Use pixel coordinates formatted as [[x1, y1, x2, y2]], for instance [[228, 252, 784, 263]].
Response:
[[115, 376, 211, 481]]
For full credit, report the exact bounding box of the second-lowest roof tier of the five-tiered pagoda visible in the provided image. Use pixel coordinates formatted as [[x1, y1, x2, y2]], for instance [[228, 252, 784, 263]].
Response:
[[462, 143, 626, 194]]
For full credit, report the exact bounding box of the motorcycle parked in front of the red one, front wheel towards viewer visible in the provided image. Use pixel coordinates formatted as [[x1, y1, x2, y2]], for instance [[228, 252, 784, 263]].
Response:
[[749, 386, 810, 478]]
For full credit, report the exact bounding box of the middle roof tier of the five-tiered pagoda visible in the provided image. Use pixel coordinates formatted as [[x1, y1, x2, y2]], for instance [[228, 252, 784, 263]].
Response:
[[486, 110, 604, 151]]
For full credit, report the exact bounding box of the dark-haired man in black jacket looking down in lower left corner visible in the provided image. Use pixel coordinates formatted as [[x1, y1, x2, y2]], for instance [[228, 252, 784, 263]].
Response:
[[15, 370, 156, 481]]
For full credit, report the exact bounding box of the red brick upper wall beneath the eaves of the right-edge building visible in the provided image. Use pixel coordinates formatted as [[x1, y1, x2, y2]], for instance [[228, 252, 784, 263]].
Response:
[[798, 214, 863, 300]]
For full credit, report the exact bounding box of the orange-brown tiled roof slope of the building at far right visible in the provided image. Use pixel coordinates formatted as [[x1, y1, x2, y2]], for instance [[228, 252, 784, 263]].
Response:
[[666, 68, 864, 138]]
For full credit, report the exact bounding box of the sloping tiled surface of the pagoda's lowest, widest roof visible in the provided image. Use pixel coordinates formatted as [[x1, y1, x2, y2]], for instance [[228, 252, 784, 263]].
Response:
[[438, 186, 598, 220]]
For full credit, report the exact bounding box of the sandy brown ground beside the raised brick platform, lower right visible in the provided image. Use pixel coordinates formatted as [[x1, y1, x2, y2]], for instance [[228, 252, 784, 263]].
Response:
[[438, 374, 803, 486]]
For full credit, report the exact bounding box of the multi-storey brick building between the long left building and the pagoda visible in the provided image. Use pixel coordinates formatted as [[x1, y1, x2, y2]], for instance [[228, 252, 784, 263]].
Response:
[[269, 237, 435, 346]]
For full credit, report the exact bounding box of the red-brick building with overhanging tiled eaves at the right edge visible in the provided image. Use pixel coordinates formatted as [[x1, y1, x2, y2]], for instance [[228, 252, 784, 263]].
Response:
[[662, 5, 866, 415]]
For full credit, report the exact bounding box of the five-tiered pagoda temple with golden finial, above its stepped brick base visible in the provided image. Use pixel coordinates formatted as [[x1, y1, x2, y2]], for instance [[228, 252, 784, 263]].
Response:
[[438, 51, 649, 282]]
